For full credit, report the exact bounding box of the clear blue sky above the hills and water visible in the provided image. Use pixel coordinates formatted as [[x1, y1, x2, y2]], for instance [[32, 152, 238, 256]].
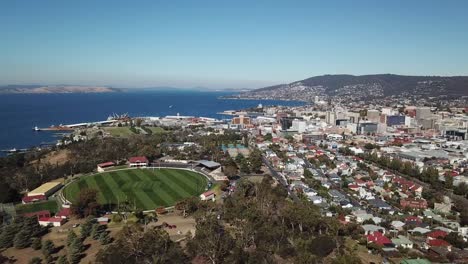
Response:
[[0, 0, 468, 88]]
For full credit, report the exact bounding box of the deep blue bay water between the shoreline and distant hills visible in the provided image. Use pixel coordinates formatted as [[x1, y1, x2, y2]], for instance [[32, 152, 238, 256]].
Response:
[[0, 91, 303, 155]]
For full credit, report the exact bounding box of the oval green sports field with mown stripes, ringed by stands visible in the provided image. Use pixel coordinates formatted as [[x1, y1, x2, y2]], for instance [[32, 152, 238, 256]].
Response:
[[63, 169, 207, 210]]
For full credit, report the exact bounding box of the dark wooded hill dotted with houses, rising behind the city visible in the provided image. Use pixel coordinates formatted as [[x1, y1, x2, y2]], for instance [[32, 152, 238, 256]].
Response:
[[235, 74, 468, 101]]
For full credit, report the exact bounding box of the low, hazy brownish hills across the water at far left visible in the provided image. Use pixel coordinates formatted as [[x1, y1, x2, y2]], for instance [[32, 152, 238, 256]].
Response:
[[0, 85, 120, 94]]
